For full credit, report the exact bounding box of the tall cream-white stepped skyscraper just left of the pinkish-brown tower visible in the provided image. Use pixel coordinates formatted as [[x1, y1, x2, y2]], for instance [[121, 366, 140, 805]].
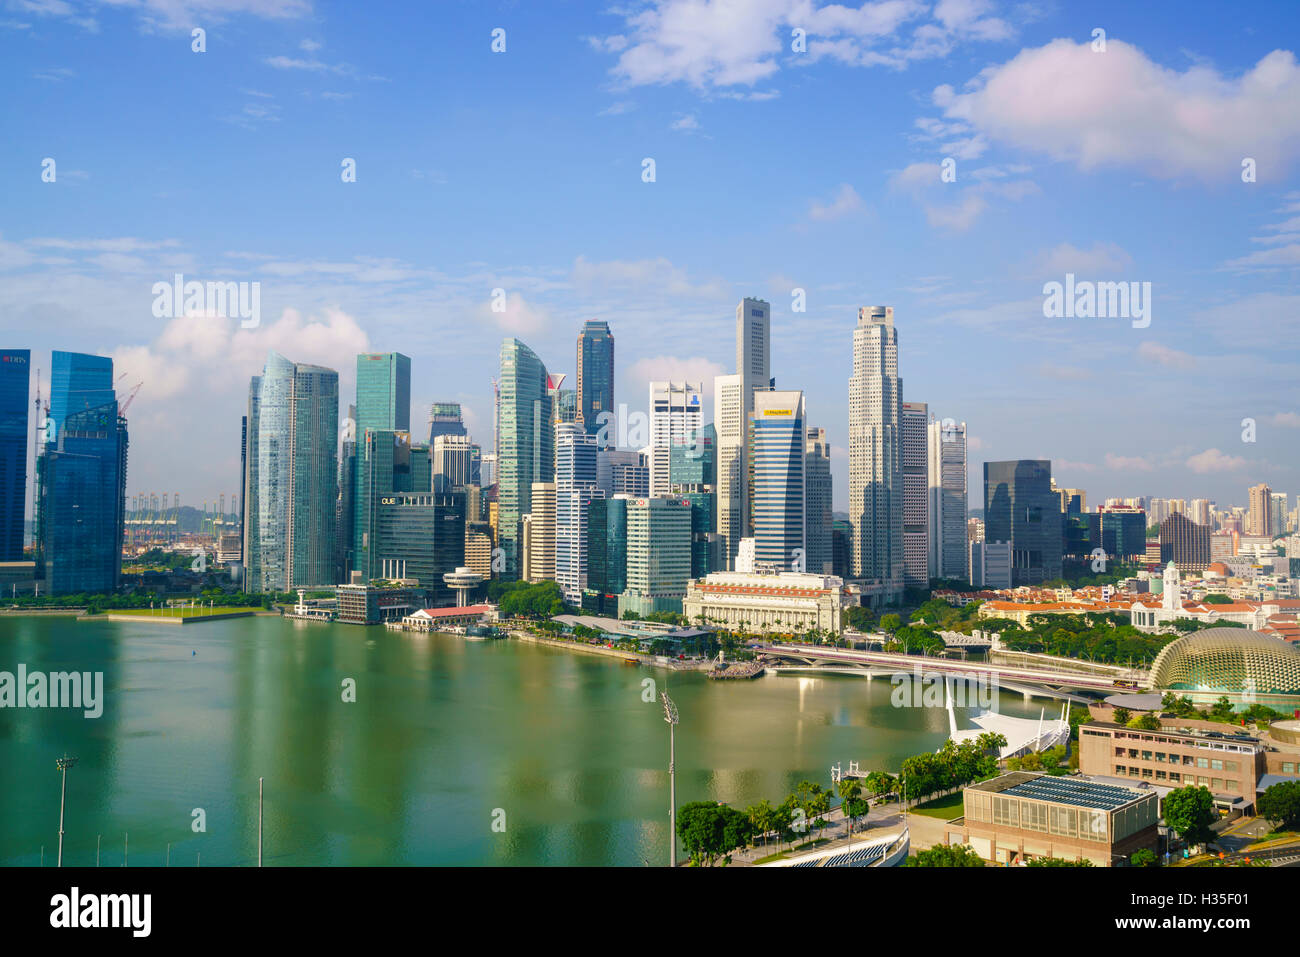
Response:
[[849, 306, 904, 601]]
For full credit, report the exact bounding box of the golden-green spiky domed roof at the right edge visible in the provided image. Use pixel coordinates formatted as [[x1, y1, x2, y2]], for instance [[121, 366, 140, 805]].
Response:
[[1151, 628, 1300, 694]]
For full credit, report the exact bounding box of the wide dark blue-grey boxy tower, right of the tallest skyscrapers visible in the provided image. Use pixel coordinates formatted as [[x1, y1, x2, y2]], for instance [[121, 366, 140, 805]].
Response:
[[984, 459, 1063, 585]]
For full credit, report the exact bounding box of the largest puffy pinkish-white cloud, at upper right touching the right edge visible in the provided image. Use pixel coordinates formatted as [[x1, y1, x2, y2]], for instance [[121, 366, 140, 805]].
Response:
[[935, 39, 1300, 183]]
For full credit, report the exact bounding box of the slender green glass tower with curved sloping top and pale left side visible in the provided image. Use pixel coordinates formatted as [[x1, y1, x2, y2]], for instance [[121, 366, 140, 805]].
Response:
[[497, 338, 555, 579]]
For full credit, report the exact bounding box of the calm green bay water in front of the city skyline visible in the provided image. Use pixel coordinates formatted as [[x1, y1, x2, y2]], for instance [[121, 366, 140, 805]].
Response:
[[0, 618, 1053, 866]]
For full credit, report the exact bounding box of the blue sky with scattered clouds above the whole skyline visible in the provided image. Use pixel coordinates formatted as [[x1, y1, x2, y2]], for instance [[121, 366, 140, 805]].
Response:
[[0, 0, 1300, 508]]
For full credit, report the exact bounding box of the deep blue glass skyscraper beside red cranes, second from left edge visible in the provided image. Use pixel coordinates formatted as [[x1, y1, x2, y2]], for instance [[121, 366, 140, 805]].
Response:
[[39, 352, 127, 594]]
